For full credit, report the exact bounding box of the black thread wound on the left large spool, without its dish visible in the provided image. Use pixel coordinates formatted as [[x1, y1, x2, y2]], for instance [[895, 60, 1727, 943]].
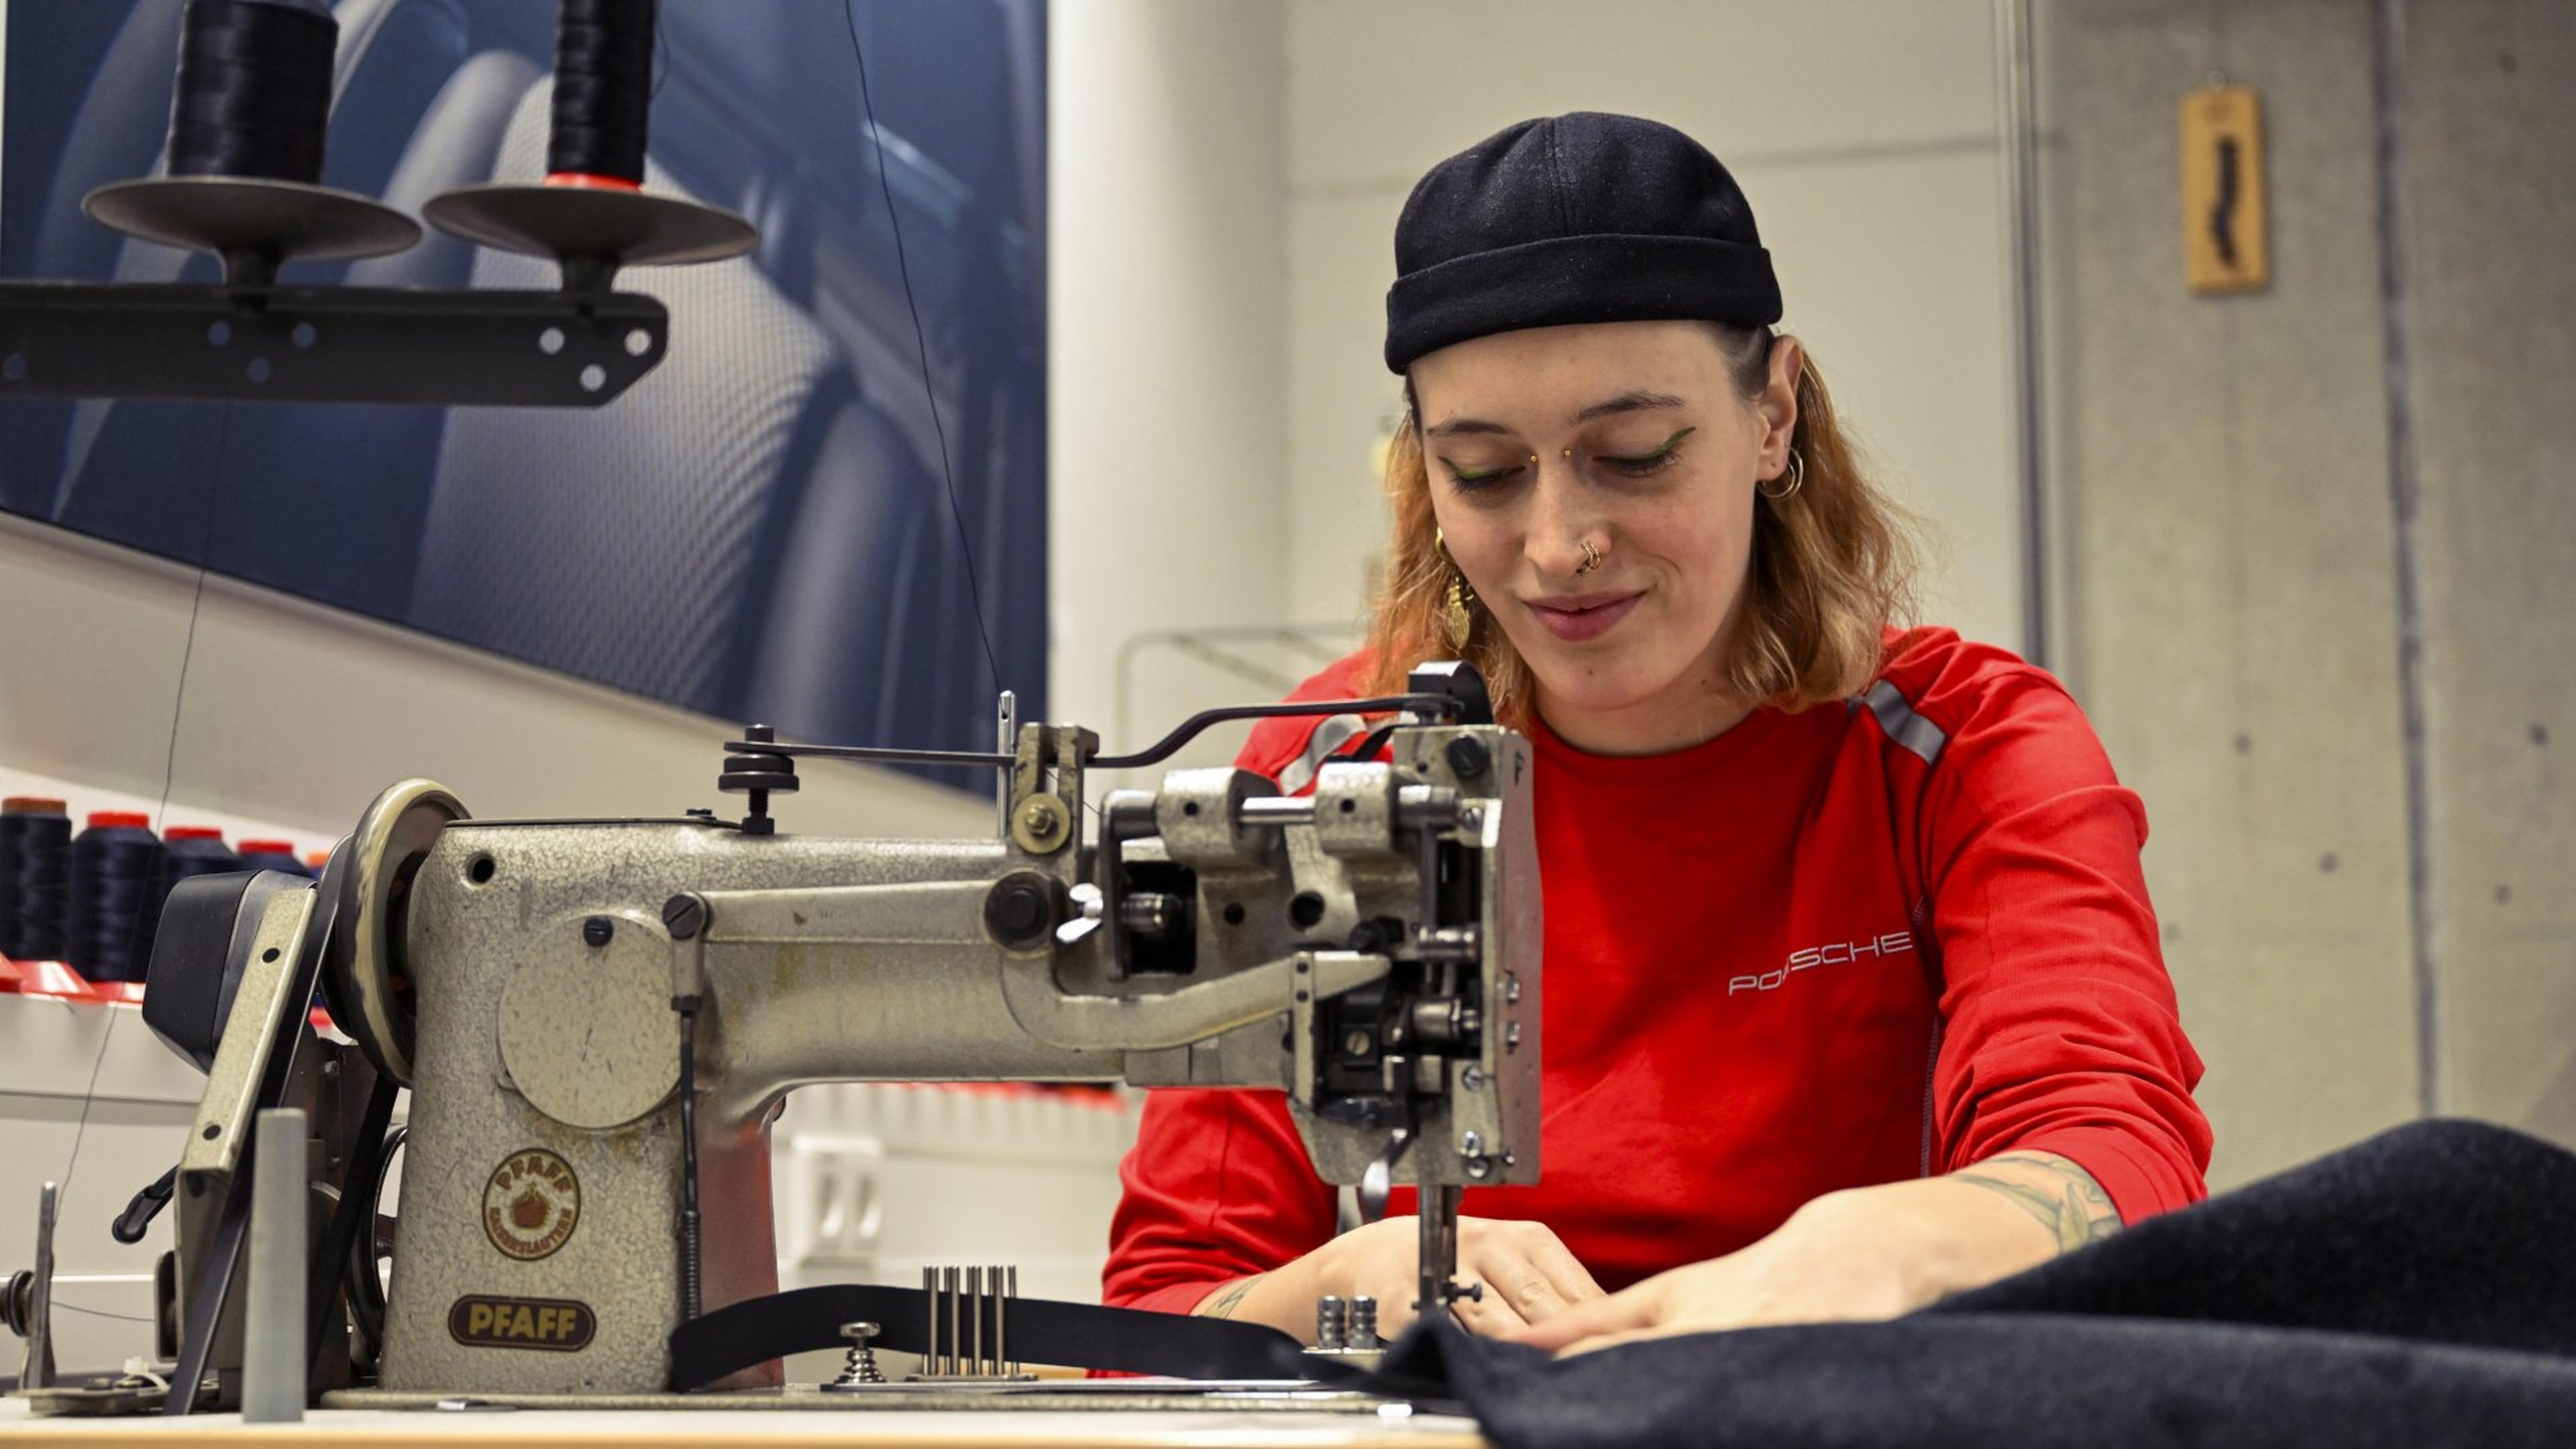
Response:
[[170, 0, 340, 186]]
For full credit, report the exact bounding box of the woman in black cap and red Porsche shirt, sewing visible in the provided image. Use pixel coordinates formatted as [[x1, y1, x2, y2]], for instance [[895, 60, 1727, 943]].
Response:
[[1108, 113, 2210, 1348]]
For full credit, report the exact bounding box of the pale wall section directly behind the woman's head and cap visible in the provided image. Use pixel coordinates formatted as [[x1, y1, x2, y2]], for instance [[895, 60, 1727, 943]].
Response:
[[1277, 0, 2022, 647]]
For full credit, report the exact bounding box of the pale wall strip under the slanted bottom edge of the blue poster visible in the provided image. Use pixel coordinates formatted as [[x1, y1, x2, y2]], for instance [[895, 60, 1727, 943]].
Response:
[[0, 519, 991, 841]]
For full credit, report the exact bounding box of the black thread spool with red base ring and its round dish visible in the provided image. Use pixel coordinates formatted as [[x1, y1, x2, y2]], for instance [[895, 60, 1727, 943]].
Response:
[[420, 0, 760, 291]]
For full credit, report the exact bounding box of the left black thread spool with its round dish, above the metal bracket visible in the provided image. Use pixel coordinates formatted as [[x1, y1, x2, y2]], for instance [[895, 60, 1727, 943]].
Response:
[[80, 0, 420, 286]]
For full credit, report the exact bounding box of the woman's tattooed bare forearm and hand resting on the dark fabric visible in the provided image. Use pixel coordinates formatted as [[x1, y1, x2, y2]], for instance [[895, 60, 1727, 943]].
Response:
[[1505, 1152, 2120, 1354]]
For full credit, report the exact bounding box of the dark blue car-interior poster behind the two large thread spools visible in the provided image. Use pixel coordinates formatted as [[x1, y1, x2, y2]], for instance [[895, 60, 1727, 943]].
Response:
[[0, 0, 1046, 789]]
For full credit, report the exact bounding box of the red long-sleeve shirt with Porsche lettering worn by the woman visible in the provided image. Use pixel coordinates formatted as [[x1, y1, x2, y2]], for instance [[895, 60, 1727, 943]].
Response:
[[1105, 629, 2210, 1312]]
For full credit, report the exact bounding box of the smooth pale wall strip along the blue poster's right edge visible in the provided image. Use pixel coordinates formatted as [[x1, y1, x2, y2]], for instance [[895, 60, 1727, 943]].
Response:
[[1049, 0, 1291, 789]]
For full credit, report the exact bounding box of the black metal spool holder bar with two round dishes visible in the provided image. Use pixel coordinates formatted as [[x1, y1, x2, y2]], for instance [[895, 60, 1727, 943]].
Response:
[[0, 178, 757, 407]]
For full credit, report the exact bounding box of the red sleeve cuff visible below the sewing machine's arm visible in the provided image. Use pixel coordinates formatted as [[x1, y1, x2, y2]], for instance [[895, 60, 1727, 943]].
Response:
[[1100, 1088, 1334, 1312]]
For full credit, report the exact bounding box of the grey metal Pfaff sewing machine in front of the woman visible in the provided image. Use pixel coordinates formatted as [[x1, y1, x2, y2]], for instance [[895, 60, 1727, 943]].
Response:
[[35, 665, 1540, 1410]]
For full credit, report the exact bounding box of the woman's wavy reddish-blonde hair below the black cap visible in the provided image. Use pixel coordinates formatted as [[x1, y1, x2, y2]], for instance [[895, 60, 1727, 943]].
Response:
[[1365, 325, 1917, 727]]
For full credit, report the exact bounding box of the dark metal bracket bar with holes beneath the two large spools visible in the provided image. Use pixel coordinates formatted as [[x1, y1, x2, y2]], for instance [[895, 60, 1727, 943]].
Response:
[[0, 281, 669, 407]]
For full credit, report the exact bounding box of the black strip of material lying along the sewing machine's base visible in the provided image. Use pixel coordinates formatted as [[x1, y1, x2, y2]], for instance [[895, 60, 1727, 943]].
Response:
[[669, 1284, 1362, 1390]]
